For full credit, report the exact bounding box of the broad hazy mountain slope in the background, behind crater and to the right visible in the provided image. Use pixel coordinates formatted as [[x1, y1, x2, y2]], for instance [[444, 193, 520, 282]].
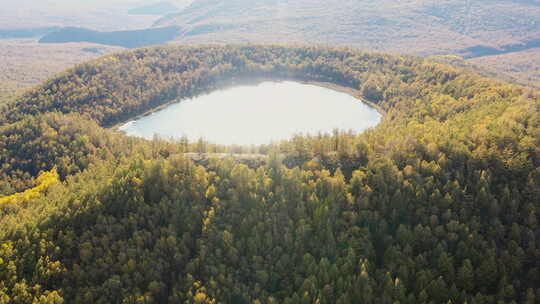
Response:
[[155, 0, 540, 57]]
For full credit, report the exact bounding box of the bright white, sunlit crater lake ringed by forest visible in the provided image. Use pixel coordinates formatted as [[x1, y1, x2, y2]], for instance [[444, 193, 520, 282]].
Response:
[[119, 81, 381, 145]]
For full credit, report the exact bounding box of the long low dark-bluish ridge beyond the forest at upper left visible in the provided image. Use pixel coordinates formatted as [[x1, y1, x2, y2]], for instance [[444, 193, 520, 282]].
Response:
[[39, 26, 180, 48]]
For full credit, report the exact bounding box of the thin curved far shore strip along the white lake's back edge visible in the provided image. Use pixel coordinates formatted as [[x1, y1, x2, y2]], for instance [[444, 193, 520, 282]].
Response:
[[112, 77, 386, 134]]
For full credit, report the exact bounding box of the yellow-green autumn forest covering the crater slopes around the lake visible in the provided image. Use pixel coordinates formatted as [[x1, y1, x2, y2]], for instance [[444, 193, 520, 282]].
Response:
[[0, 45, 540, 304]]
